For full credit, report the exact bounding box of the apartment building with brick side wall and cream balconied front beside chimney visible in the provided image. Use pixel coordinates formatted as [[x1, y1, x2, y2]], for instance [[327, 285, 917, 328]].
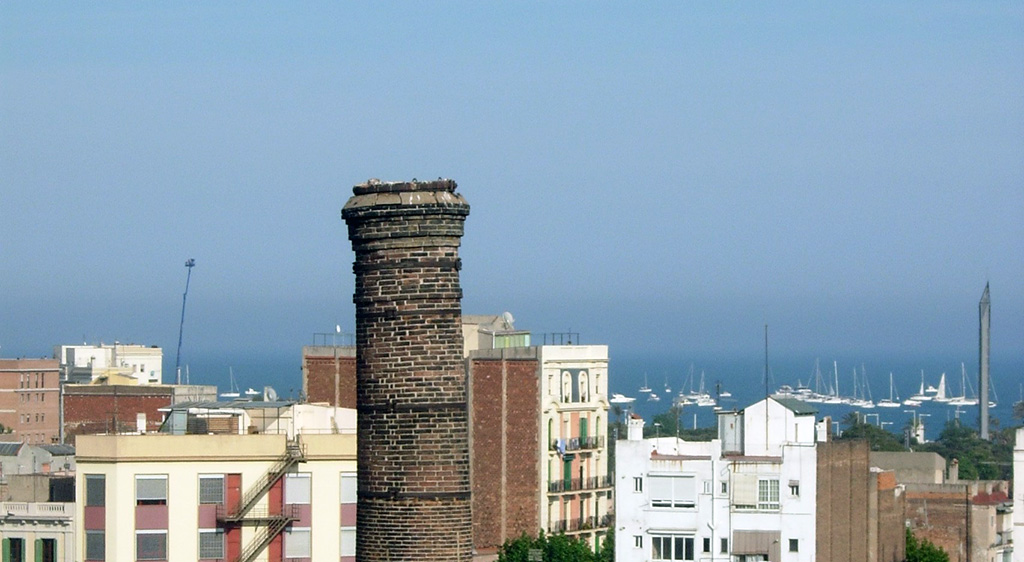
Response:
[[467, 336, 614, 553]]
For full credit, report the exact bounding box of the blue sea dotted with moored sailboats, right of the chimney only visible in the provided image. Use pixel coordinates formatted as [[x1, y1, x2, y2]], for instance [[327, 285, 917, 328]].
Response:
[[609, 355, 1024, 439]]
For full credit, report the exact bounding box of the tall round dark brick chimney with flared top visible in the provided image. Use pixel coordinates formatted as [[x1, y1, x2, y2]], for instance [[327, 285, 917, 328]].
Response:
[[341, 179, 472, 561]]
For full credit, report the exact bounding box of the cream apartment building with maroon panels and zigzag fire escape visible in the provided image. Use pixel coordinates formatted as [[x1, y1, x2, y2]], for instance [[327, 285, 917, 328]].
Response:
[[76, 402, 356, 562]]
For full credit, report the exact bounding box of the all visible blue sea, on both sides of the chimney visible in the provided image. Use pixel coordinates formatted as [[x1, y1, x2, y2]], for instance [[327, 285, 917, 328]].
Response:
[[164, 349, 1024, 439]]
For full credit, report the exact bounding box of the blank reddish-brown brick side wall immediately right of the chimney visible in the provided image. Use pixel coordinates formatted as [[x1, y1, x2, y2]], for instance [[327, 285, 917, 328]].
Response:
[[469, 358, 542, 553]]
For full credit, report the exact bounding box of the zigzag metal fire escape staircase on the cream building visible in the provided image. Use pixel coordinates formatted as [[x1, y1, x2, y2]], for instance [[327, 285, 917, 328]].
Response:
[[217, 439, 305, 562]]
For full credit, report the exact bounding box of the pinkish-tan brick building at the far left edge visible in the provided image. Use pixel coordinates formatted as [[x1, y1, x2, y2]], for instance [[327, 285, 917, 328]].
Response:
[[0, 359, 60, 444]]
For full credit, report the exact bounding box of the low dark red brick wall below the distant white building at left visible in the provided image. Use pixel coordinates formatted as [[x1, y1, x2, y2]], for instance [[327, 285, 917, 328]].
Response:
[[63, 385, 172, 445]]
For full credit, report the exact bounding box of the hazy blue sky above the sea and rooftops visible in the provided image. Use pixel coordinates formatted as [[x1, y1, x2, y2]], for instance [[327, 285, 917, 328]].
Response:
[[0, 2, 1024, 360]]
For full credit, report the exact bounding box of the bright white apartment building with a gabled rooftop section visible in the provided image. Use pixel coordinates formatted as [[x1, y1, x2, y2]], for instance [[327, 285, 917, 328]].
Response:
[[615, 398, 817, 562]]
